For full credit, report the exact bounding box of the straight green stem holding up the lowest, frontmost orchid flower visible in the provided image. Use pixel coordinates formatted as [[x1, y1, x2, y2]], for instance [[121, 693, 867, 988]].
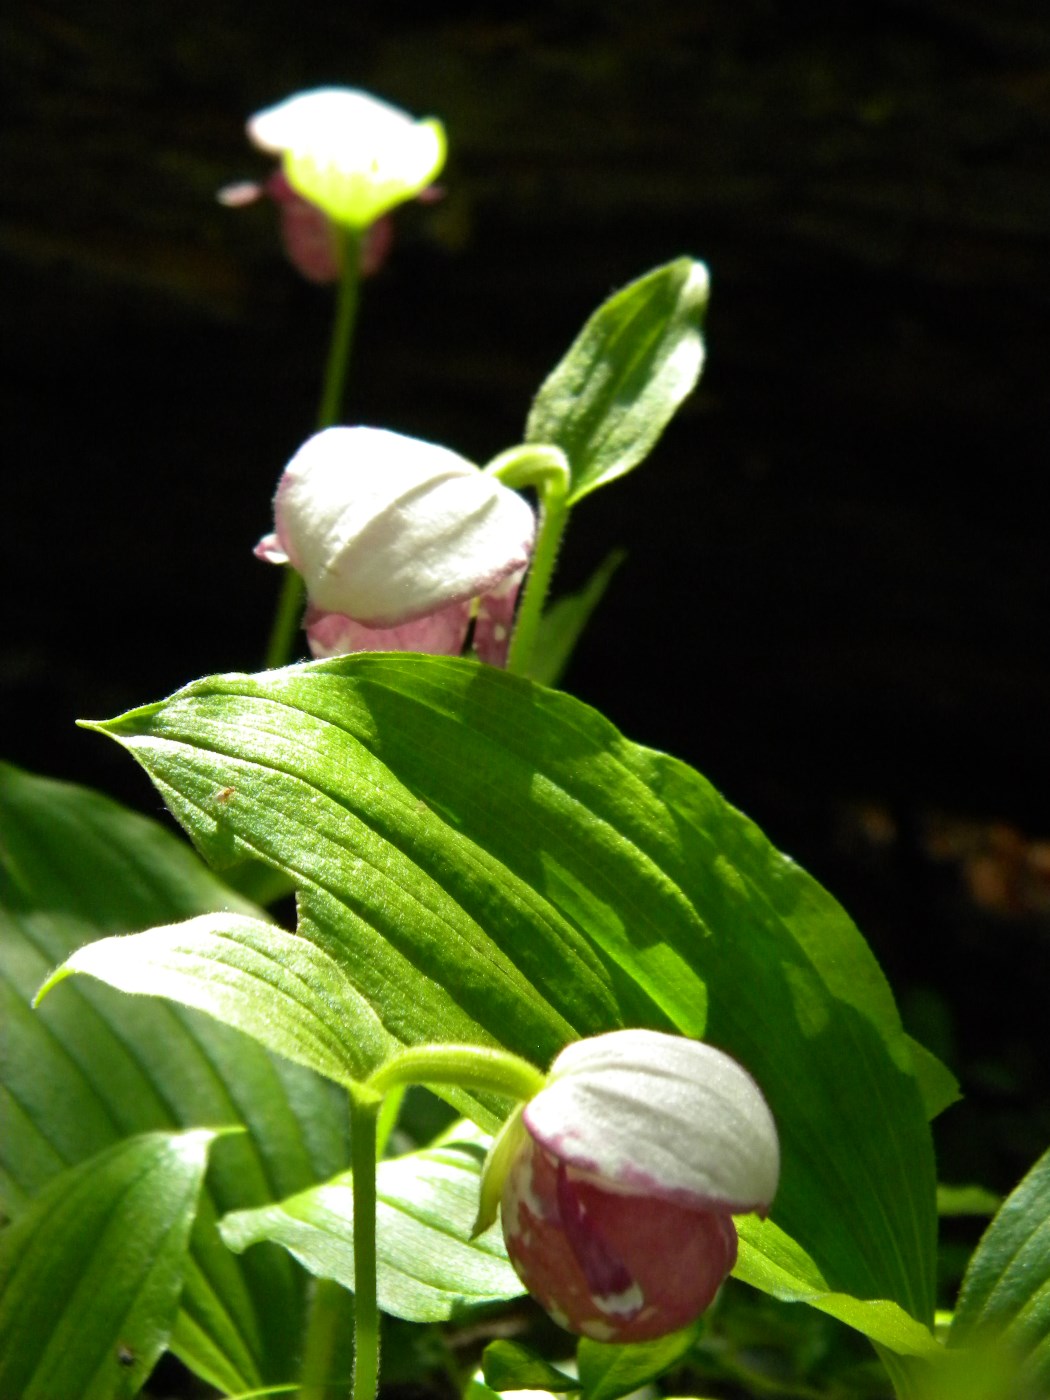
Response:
[[350, 1089, 381, 1400]]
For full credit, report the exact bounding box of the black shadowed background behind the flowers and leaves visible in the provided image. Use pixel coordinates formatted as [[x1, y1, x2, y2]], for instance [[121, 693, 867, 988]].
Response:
[[0, 0, 1050, 1204]]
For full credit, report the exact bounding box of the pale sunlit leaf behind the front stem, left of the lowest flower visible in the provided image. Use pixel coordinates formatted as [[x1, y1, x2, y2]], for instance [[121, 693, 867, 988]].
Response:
[[220, 1123, 525, 1322]]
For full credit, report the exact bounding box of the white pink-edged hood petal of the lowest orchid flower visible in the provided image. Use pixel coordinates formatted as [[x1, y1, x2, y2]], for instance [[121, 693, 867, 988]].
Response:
[[525, 1030, 780, 1212]]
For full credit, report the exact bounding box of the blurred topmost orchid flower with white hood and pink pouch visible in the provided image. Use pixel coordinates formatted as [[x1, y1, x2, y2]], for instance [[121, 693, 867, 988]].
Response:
[[218, 88, 445, 283]]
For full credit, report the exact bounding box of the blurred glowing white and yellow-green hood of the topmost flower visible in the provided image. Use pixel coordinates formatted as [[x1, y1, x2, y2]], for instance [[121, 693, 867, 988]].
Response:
[[248, 88, 445, 231]]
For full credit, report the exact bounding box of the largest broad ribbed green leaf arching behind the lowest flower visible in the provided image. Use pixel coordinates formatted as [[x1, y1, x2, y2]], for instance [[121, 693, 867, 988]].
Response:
[[82, 655, 937, 1320]]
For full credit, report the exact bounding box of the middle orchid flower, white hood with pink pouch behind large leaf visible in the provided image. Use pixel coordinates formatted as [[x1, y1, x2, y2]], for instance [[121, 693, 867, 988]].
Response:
[[255, 427, 535, 665]]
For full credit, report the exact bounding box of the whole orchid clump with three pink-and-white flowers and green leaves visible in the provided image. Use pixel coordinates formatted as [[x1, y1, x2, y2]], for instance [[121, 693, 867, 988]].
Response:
[[0, 90, 1050, 1400]]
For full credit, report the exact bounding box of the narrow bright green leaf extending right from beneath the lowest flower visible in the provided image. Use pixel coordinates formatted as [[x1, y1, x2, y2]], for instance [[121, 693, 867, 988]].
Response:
[[732, 1217, 942, 1361]]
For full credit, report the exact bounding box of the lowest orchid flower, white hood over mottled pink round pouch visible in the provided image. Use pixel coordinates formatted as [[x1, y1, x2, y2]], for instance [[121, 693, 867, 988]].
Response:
[[483, 1030, 780, 1341]]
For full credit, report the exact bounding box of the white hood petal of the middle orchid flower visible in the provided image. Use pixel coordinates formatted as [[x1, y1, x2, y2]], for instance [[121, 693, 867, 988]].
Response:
[[276, 428, 535, 627]]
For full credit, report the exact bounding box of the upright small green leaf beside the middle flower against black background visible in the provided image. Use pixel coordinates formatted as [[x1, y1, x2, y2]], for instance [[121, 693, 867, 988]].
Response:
[[525, 258, 707, 504]]
